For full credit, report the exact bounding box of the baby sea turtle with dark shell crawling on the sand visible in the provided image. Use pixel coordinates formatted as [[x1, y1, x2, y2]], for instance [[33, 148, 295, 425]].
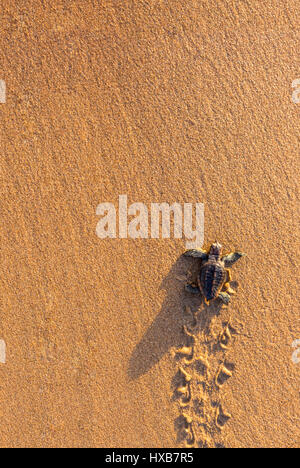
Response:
[[184, 242, 245, 304]]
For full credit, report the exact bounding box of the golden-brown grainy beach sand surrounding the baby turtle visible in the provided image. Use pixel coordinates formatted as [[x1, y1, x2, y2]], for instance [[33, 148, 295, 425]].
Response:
[[0, 0, 300, 447]]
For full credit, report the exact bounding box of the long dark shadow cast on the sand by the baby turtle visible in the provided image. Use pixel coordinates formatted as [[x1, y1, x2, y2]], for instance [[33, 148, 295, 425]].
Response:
[[127, 255, 222, 380]]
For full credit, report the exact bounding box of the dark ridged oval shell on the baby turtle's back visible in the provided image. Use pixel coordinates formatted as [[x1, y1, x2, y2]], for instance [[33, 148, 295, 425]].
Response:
[[198, 260, 226, 301]]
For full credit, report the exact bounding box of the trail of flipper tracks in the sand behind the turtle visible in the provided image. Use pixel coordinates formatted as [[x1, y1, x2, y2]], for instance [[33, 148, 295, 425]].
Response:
[[173, 307, 237, 448]]
